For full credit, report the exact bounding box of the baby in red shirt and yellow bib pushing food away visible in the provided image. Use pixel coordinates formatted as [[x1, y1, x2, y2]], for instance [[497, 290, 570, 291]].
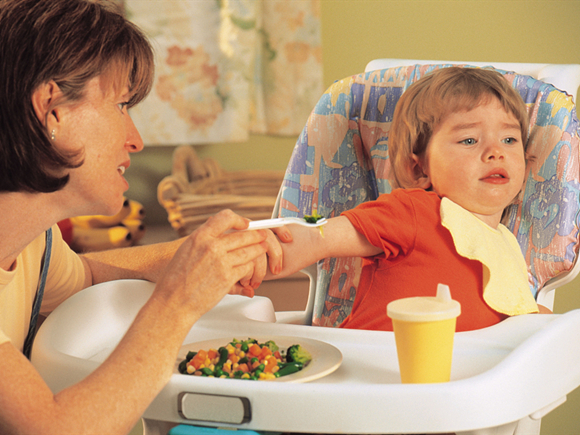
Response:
[[269, 67, 539, 331]]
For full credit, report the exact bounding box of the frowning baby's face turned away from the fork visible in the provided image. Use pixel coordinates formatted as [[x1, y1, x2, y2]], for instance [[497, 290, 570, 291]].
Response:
[[421, 98, 526, 228]]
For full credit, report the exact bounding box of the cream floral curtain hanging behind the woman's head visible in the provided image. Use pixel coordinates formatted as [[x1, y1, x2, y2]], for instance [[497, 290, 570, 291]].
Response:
[[123, 0, 323, 145]]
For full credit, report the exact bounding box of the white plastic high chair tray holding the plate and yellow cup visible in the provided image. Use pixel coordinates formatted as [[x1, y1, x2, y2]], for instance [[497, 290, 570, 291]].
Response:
[[32, 280, 580, 433]]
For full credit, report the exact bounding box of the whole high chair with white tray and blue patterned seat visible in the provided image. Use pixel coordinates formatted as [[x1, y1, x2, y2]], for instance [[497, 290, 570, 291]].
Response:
[[32, 61, 580, 435]]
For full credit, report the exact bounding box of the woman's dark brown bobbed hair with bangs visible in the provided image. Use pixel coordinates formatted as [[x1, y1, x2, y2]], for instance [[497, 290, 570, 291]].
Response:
[[0, 0, 154, 192]]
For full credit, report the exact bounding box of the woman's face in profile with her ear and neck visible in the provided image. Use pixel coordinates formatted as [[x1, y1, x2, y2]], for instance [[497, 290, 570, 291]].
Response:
[[55, 77, 143, 215]]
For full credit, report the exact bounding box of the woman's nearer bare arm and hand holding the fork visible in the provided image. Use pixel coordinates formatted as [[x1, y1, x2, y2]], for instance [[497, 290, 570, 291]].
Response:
[[0, 212, 266, 435]]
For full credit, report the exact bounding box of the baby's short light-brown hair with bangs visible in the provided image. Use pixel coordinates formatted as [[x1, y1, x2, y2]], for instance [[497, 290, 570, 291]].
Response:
[[389, 67, 529, 188]]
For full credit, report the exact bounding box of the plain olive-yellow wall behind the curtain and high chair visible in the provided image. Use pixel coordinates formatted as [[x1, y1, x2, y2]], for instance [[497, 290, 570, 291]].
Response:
[[128, 0, 580, 435]]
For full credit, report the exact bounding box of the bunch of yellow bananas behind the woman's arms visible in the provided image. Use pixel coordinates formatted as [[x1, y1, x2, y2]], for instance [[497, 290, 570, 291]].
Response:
[[59, 198, 145, 252]]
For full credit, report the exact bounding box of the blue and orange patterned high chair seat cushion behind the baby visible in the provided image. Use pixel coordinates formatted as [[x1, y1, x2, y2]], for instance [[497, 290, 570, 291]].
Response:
[[279, 64, 580, 326]]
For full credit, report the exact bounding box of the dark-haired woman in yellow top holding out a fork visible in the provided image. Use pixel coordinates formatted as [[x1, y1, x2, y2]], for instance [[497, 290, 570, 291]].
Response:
[[0, 0, 281, 434]]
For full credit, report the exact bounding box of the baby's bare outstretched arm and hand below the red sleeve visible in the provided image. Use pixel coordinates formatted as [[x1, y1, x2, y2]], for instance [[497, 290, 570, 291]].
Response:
[[264, 216, 382, 280]]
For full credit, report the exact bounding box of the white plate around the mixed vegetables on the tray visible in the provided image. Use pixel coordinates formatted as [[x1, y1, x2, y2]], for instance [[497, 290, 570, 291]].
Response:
[[175, 336, 342, 382]]
